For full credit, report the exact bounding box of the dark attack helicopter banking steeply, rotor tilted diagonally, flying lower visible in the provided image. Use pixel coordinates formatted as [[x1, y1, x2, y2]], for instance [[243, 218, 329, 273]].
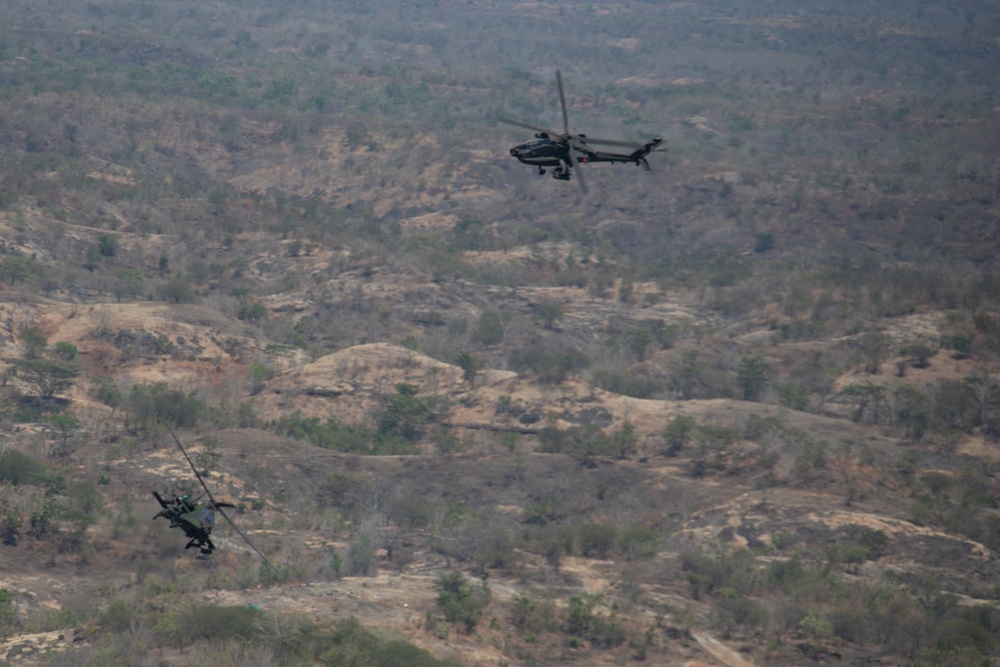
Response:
[[152, 426, 278, 572]]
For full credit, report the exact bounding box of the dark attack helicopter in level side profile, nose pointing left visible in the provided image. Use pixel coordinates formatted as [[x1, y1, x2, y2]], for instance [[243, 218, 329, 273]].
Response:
[[500, 70, 664, 194]]
